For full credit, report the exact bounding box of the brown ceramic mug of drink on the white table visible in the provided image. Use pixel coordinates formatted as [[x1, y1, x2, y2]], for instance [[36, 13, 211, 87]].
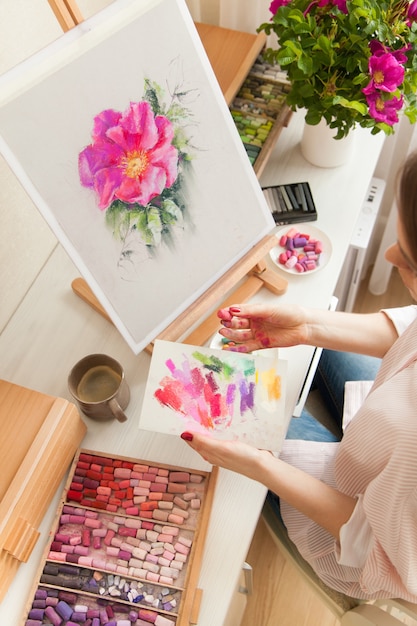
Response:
[[68, 354, 130, 422]]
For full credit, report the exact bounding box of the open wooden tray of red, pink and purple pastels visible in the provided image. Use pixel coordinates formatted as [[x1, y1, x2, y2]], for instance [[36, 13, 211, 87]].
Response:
[[22, 450, 216, 626]]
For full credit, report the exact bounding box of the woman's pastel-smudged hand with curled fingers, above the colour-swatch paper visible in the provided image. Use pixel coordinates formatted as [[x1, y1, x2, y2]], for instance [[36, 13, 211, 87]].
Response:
[[217, 304, 308, 352]]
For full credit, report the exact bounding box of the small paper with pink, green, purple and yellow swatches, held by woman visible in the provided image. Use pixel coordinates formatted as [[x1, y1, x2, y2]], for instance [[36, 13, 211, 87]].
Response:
[[139, 340, 286, 451]]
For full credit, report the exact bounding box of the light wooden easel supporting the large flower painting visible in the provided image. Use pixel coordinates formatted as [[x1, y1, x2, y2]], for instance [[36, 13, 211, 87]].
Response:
[[48, 0, 288, 352]]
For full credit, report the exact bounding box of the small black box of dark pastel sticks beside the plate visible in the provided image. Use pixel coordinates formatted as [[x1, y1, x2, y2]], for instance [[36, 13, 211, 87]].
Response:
[[262, 182, 317, 225]]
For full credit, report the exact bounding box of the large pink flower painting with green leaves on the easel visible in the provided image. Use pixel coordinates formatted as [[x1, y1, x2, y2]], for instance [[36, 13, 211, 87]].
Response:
[[0, 0, 274, 353]]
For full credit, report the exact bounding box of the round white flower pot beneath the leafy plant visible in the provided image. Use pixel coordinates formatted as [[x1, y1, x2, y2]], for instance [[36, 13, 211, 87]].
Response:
[[301, 119, 355, 167]]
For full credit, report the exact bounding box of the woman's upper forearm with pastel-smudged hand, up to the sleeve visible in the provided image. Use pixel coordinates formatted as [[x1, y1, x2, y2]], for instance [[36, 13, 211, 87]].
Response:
[[218, 304, 398, 357]]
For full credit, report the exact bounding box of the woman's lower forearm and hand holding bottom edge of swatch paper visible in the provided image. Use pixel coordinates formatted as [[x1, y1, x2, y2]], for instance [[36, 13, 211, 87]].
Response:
[[181, 433, 356, 539]]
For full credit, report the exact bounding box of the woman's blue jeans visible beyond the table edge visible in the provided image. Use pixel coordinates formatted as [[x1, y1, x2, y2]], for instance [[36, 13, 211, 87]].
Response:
[[287, 350, 381, 441]]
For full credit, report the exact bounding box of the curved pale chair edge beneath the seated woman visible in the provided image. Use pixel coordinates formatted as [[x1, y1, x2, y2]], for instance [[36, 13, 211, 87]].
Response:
[[262, 499, 417, 626]]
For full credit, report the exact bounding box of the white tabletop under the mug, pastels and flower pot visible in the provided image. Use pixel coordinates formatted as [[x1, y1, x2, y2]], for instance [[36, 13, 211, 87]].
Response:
[[0, 114, 383, 626]]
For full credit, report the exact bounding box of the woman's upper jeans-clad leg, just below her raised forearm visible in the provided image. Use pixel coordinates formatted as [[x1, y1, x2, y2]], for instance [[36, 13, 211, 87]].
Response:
[[313, 350, 381, 429]]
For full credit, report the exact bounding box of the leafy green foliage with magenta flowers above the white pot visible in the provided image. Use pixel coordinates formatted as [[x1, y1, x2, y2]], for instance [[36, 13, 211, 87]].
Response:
[[258, 0, 417, 139]]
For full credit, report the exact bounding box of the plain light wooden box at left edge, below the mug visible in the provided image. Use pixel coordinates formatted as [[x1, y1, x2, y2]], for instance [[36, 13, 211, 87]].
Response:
[[0, 380, 87, 602]]
